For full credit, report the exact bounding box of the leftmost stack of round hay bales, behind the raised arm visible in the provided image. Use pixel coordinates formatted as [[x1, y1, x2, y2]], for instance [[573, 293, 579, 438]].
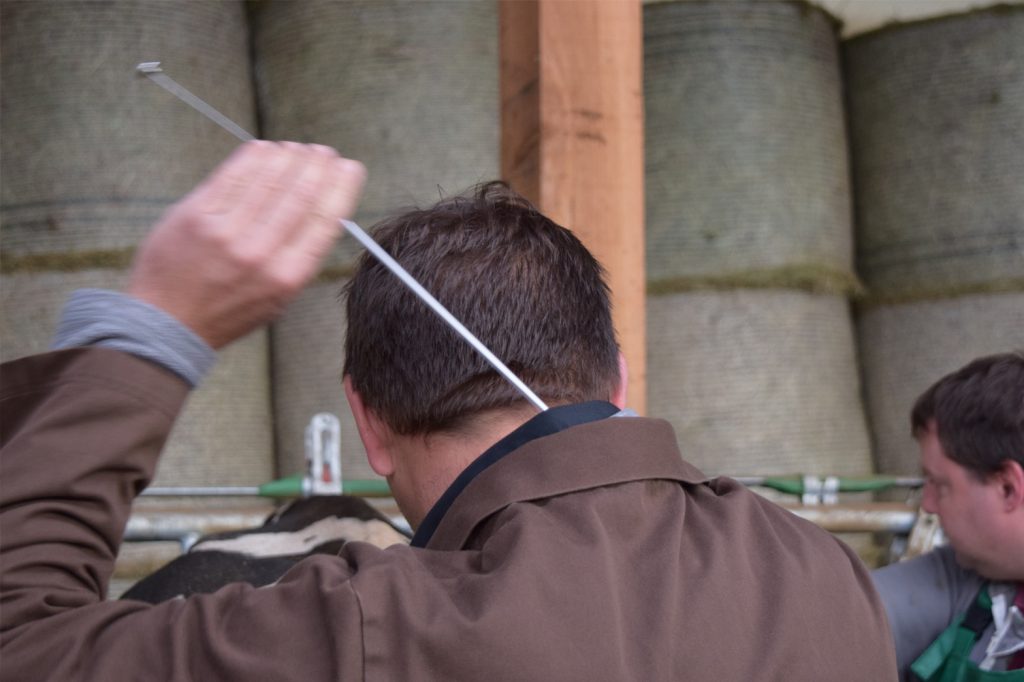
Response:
[[0, 2, 274, 497]]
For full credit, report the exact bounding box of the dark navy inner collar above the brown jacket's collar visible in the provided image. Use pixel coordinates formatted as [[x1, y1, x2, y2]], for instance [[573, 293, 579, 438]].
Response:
[[412, 400, 618, 547]]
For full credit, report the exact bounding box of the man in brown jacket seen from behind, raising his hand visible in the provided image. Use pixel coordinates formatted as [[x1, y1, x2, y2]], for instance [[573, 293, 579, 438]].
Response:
[[0, 143, 895, 682]]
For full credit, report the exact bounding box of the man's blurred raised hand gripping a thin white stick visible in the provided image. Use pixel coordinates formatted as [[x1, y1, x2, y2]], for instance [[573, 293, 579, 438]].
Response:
[[128, 140, 366, 348]]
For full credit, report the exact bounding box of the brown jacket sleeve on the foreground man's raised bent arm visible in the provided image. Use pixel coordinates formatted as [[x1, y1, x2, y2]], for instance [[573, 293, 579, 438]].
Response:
[[0, 348, 361, 680]]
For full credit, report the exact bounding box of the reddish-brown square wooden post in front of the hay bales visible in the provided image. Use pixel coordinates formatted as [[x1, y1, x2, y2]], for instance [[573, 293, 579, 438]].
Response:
[[500, 0, 646, 413]]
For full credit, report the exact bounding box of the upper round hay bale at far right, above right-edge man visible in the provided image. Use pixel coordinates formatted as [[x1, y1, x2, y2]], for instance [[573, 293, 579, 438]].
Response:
[[844, 6, 1024, 301]]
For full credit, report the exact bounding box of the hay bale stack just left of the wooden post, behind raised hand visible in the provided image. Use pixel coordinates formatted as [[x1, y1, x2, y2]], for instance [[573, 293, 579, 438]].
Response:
[[252, 0, 500, 476]]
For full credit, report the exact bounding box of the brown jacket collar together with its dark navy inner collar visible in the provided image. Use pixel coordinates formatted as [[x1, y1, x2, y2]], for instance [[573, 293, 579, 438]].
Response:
[[413, 402, 708, 550]]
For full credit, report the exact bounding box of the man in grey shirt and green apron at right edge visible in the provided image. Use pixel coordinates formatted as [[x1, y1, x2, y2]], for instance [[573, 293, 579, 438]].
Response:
[[874, 352, 1024, 681]]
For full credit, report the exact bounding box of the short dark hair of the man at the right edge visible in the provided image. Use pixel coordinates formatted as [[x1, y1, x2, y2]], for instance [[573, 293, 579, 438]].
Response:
[[910, 351, 1024, 479]]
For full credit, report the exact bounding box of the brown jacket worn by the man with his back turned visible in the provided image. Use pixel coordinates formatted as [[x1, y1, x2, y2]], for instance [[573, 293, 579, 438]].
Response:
[[0, 349, 896, 682]]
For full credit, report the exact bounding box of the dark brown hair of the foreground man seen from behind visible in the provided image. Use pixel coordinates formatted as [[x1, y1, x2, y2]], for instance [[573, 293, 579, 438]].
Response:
[[343, 182, 618, 435]]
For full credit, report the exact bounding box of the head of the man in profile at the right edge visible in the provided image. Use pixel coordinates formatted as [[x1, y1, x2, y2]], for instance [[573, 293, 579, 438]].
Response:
[[910, 353, 1024, 580]]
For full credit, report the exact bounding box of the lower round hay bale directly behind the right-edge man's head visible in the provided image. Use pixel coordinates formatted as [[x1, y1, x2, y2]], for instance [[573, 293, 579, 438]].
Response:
[[858, 293, 1024, 474]]
